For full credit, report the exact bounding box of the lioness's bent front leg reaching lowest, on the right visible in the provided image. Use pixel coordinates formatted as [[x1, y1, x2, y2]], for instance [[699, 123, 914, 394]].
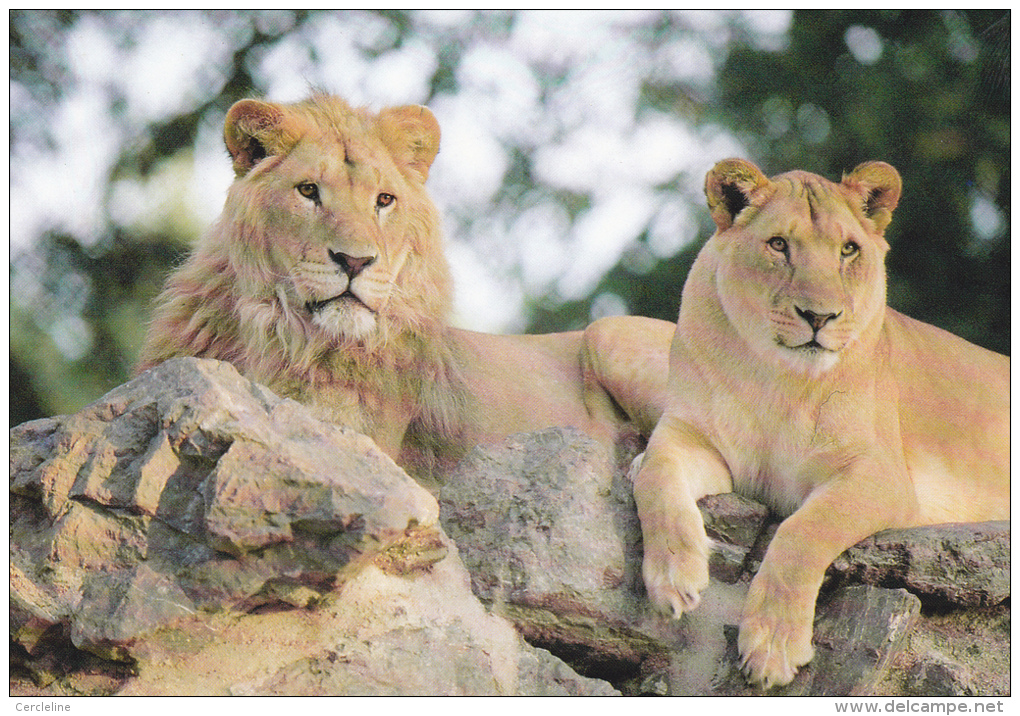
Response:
[[737, 471, 914, 687]]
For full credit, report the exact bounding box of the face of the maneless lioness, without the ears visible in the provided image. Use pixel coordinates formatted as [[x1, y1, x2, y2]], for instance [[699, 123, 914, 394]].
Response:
[[714, 175, 887, 372]]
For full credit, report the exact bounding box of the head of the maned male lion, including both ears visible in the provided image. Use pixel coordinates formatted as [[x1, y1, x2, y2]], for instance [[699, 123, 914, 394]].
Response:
[[225, 99, 449, 343]]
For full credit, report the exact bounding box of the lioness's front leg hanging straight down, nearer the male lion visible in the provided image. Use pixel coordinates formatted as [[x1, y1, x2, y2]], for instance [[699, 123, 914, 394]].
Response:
[[634, 415, 732, 616]]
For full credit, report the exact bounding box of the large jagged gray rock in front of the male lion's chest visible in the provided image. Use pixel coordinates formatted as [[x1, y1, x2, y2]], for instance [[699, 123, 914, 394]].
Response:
[[10, 359, 442, 654]]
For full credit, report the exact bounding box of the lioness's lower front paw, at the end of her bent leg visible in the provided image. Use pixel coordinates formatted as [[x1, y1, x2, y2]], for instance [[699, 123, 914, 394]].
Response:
[[737, 584, 815, 688]]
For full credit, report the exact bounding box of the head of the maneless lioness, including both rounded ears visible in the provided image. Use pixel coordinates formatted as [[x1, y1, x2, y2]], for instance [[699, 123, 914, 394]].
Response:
[[707, 160, 900, 372]]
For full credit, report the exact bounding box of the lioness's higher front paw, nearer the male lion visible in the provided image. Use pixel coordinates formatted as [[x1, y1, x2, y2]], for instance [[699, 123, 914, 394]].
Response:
[[642, 529, 709, 617]]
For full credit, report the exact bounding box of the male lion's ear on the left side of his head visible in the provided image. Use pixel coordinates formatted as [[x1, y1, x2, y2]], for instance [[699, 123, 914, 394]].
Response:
[[223, 100, 298, 176]]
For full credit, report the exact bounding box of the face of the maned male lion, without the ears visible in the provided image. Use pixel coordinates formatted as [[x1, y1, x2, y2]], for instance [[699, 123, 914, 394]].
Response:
[[250, 136, 410, 339]]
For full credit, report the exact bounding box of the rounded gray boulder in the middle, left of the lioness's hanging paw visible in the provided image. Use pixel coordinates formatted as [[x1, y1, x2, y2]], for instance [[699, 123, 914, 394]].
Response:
[[440, 428, 669, 677]]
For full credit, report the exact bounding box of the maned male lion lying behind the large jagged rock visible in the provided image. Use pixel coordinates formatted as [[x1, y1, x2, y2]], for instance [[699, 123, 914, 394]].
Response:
[[140, 91, 672, 477]]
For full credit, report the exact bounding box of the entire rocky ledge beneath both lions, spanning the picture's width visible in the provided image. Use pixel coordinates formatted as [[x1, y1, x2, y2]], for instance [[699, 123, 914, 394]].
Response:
[[10, 359, 1010, 696]]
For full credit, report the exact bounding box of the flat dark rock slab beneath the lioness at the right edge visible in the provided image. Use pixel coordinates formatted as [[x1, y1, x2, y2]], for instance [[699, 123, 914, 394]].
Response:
[[829, 521, 1010, 607]]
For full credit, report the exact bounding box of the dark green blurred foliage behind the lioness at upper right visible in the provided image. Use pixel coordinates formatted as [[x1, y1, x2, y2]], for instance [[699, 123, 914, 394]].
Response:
[[532, 10, 1010, 346]]
